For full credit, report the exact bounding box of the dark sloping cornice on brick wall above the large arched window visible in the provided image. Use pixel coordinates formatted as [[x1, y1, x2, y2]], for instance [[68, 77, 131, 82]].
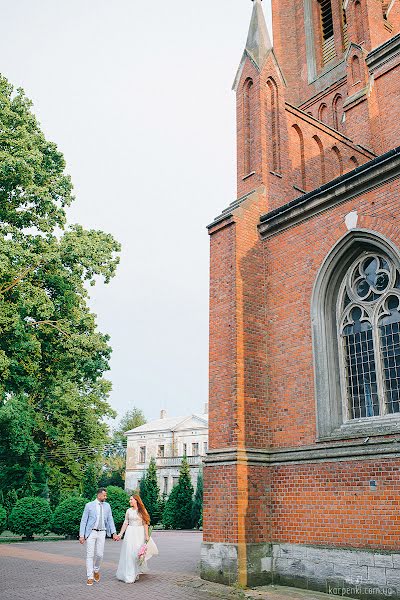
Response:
[[258, 146, 400, 238]]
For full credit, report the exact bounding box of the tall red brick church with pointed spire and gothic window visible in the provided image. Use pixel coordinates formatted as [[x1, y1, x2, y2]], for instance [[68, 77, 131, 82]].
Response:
[[201, 0, 400, 598]]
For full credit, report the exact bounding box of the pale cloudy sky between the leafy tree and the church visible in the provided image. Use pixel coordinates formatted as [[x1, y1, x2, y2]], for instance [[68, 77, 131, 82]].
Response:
[[0, 0, 271, 420]]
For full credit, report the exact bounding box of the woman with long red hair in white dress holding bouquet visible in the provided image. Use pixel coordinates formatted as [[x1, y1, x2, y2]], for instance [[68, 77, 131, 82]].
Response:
[[117, 494, 158, 583]]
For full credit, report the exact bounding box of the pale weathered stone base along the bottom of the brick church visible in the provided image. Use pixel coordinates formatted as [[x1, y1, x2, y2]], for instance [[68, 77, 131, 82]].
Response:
[[201, 543, 400, 600]]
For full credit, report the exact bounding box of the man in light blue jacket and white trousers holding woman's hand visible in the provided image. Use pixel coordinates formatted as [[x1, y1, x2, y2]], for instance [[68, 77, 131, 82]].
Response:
[[79, 488, 121, 585]]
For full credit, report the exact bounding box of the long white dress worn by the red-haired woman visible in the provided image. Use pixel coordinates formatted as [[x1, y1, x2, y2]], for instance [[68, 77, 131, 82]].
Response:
[[117, 508, 158, 583]]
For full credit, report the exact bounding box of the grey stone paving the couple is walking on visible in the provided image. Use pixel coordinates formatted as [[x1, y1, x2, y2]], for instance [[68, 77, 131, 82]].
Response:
[[0, 531, 350, 600]]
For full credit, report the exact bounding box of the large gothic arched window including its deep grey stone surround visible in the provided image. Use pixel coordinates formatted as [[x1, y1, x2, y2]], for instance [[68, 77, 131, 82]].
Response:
[[311, 229, 400, 440]]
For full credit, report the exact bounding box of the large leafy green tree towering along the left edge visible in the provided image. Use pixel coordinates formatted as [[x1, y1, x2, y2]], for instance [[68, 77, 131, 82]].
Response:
[[0, 76, 120, 496]]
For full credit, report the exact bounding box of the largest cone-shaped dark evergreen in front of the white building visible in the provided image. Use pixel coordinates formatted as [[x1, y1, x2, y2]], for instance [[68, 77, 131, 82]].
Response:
[[163, 457, 193, 529]]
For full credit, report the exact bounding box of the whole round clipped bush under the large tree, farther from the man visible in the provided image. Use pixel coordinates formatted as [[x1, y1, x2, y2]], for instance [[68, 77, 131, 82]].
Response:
[[8, 496, 53, 538]]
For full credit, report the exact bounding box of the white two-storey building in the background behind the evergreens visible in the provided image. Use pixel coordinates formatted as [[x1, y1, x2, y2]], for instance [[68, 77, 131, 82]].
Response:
[[125, 405, 208, 494]]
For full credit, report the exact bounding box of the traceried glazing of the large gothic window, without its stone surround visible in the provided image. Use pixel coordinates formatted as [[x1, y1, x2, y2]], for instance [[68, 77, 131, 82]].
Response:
[[337, 252, 400, 420]]
